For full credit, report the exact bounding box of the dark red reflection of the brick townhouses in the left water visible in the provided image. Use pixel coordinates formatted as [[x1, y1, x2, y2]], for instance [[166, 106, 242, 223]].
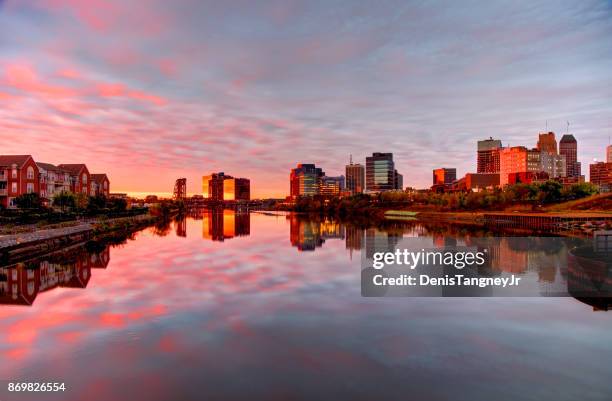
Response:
[[0, 246, 110, 305]]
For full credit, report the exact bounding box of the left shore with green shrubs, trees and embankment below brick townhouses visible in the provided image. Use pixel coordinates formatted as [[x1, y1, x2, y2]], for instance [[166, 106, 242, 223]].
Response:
[[0, 193, 185, 263]]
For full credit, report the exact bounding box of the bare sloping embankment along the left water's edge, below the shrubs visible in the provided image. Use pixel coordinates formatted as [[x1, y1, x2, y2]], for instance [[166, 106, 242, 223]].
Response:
[[0, 214, 157, 262]]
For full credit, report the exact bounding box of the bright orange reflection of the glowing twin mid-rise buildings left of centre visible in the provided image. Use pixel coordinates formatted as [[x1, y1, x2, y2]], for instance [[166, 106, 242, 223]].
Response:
[[202, 210, 251, 241]]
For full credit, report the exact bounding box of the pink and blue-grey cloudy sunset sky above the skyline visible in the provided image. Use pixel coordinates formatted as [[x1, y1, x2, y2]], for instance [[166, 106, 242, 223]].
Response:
[[0, 0, 612, 197]]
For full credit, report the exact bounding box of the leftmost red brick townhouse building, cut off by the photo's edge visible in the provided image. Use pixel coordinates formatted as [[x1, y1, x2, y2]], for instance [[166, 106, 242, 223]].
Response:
[[0, 155, 40, 207]]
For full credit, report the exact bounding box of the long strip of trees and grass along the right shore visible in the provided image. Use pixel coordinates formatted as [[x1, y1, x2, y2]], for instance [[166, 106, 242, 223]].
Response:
[[277, 181, 612, 231]]
